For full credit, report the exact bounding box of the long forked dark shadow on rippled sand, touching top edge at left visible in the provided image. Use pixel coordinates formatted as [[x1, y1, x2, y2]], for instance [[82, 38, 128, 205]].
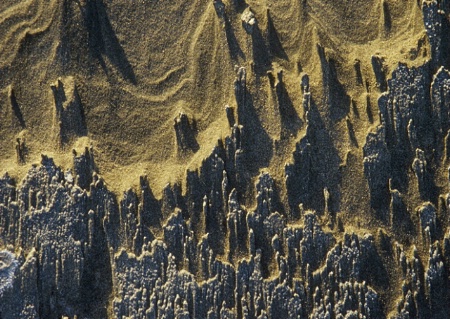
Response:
[[79, 0, 137, 84]]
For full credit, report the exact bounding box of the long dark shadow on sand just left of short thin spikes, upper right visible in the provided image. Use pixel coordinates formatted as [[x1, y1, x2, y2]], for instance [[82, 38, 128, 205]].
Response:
[[317, 45, 350, 121]]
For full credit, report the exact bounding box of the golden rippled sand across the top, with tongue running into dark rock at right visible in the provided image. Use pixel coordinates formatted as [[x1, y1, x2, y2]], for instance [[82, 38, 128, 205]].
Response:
[[0, 0, 447, 318]]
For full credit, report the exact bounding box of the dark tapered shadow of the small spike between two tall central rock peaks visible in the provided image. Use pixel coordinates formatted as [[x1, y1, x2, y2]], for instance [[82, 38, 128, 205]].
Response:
[[275, 71, 303, 139]]
